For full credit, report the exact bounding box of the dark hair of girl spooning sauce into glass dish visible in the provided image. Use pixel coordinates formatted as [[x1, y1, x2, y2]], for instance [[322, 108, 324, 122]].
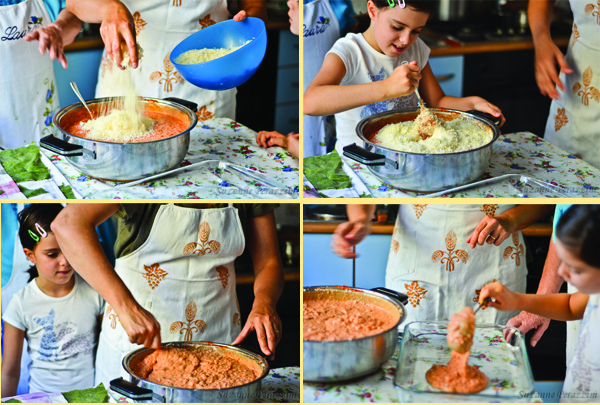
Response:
[[556, 205, 600, 268]]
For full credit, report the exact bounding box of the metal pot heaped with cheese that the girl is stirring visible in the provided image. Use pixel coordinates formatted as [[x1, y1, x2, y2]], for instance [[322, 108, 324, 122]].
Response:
[[344, 108, 500, 192]]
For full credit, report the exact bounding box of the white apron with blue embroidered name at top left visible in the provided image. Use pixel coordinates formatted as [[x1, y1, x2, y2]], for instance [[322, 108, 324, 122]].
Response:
[[0, 0, 59, 149]]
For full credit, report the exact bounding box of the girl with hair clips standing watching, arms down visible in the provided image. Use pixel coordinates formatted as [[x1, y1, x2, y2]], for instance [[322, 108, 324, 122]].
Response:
[[2, 204, 104, 398]]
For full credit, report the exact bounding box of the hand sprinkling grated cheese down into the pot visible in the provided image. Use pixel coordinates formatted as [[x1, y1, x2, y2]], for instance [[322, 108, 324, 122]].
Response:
[[100, 2, 139, 69]]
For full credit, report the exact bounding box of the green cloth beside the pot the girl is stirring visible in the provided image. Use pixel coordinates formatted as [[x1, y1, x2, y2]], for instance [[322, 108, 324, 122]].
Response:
[[304, 150, 352, 190]]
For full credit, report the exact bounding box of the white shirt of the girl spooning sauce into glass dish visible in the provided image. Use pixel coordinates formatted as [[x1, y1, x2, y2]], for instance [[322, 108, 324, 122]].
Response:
[[561, 294, 600, 402]]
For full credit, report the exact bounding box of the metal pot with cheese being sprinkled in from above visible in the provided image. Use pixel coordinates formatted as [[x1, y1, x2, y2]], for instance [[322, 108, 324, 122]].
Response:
[[40, 97, 198, 181]]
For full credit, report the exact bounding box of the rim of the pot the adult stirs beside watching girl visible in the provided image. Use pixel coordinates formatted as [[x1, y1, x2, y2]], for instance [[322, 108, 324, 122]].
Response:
[[122, 340, 269, 392]]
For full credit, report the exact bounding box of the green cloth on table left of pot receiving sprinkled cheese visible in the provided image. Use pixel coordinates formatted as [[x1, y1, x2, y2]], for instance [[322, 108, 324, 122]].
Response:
[[0, 143, 51, 183]]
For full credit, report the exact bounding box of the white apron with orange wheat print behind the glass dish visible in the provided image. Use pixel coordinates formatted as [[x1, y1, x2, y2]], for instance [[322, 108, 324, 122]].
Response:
[[385, 204, 527, 325]]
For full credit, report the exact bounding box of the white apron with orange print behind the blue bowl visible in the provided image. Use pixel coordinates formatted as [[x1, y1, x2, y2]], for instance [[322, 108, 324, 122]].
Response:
[[96, 0, 237, 120]]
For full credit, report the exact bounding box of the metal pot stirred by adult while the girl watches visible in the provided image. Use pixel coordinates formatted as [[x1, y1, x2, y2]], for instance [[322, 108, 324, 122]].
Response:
[[110, 341, 269, 403]]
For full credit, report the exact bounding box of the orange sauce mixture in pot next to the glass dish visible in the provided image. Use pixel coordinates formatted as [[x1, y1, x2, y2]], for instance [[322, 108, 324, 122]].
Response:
[[302, 298, 399, 341]]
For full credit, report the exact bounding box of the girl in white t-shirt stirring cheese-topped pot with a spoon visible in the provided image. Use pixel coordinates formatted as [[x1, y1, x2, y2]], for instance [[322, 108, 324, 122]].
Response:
[[304, 0, 504, 154]]
